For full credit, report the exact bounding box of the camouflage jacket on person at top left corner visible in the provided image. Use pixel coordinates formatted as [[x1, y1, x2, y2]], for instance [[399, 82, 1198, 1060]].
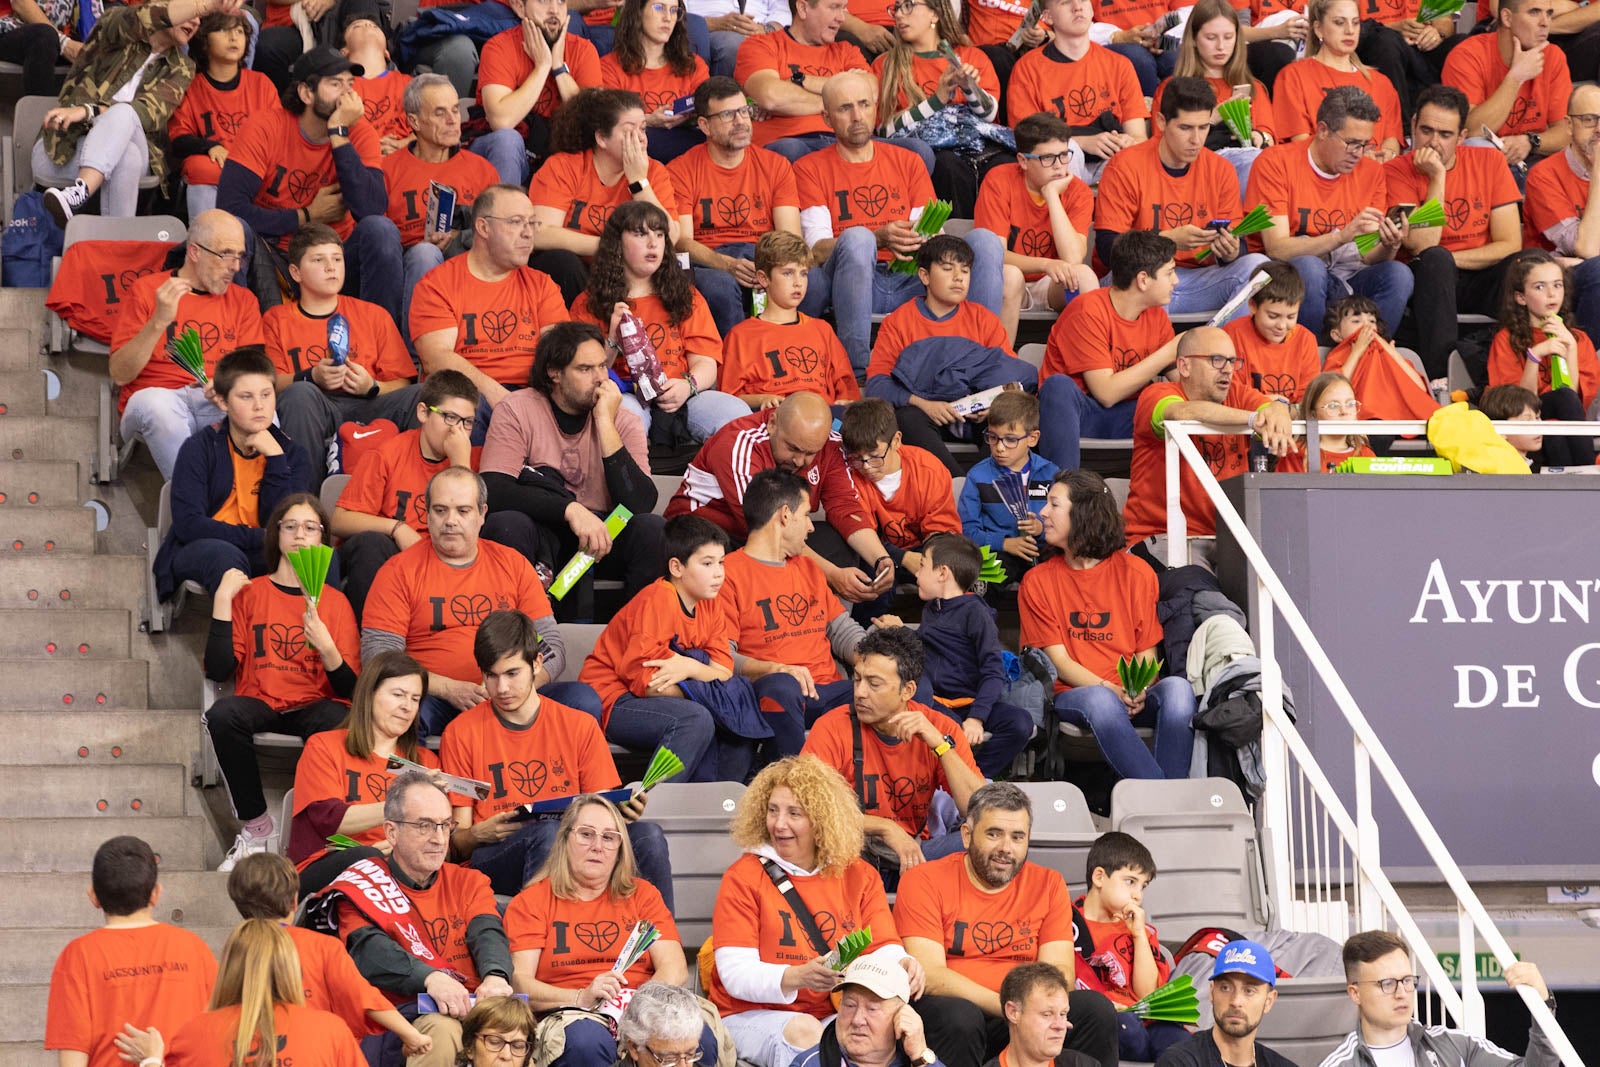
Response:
[[43, 3, 195, 181]]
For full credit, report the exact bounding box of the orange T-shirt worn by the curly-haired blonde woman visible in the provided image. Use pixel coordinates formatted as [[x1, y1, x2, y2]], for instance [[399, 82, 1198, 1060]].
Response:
[[707, 851, 902, 1019]]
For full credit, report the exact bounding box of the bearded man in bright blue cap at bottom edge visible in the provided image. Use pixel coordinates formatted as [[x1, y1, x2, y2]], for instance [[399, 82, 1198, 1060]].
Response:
[[1152, 941, 1293, 1067]]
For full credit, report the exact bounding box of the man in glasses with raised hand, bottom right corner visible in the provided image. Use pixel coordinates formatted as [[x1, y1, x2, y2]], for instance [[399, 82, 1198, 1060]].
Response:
[[1322, 929, 1562, 1067]]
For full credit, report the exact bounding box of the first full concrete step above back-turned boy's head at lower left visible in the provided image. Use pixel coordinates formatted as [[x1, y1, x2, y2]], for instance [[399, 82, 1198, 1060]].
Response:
[[0, 761, 189, 819]]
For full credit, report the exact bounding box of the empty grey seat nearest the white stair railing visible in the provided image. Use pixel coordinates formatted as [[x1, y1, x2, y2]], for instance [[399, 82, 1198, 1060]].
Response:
[[1110, 777, 1269, 944]]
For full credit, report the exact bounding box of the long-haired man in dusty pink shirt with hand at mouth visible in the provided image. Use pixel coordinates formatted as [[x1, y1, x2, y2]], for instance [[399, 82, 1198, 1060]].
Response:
[[478, 322, 664, 622]]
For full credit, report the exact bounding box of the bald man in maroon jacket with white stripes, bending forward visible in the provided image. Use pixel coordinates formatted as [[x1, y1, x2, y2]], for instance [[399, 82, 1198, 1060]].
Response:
[[667, 392, 894, 603]]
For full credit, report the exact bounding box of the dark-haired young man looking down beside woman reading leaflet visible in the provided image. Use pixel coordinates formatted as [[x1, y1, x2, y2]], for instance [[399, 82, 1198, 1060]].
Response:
[[438, 611, 672, 910]]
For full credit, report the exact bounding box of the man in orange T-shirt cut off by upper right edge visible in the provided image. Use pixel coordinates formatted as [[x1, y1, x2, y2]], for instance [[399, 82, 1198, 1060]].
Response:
[[1523, 85, 1600, 338]]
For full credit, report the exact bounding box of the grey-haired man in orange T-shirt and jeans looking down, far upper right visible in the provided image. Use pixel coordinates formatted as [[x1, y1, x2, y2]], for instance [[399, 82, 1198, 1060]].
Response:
[[1245, 85, 1414, 339]]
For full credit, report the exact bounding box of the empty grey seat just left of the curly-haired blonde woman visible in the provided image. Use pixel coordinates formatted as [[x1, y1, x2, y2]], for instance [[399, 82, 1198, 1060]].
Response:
[[645, 782, 744, 960]]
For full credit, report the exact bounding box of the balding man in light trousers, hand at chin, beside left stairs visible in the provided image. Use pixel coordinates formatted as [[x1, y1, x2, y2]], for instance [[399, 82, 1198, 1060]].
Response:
[[107, 208, 264, 480]]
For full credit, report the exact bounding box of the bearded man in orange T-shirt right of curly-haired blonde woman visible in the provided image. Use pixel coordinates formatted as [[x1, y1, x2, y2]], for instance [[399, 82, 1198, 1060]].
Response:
[[894, 782, 1117, 1067]]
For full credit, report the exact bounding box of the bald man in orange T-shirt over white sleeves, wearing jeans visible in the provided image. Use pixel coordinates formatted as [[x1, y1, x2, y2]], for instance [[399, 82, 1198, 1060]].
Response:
[[795, 70, 1022, 379]]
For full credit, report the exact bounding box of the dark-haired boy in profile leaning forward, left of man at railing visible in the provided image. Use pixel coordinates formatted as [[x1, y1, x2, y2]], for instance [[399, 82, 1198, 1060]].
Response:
[[1038, 230, 1178, 470]]
